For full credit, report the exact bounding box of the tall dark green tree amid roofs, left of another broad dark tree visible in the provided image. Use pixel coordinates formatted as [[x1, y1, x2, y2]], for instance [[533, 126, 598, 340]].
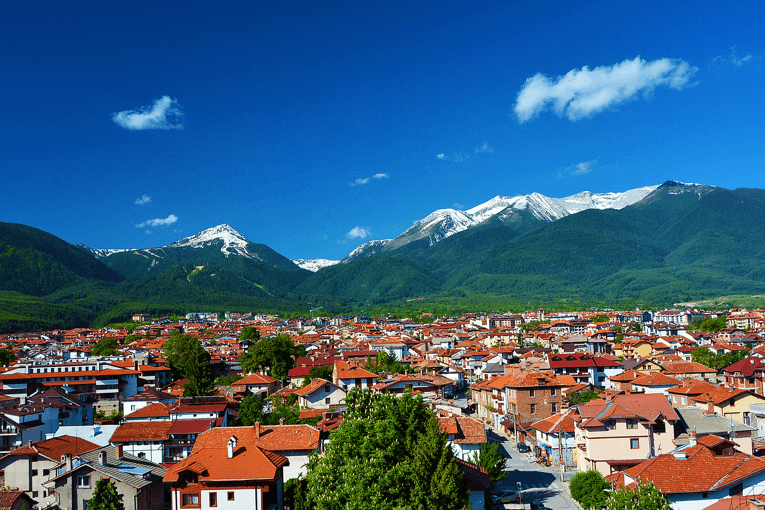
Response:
[[162, 335, 213, 396]]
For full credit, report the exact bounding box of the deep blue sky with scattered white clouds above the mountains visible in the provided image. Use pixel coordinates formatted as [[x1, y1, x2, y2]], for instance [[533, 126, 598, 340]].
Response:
[[0, 1, 765, 259]]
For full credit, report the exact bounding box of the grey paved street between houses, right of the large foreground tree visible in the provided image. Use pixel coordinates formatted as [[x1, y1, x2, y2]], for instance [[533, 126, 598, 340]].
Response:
[[490, 433, 580, 510]]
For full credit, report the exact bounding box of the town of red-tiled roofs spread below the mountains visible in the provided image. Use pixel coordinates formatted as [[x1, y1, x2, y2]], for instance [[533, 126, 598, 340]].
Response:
[[0, 309, 765, 510]]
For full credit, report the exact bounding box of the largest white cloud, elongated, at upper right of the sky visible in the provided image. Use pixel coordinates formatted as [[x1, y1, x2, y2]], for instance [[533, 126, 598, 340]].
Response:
[[515, 57, 698, 123]]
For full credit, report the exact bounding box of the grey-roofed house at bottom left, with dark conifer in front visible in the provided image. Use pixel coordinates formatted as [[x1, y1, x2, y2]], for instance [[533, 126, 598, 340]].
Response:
[[44, 446, 166, 510]]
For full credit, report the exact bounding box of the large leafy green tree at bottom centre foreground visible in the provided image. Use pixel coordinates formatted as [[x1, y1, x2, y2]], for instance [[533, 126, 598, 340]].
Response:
[[307, 389, 470, 510]]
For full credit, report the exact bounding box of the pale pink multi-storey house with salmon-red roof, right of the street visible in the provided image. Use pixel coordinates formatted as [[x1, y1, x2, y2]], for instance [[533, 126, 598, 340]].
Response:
[[571, 393, 680, 476]]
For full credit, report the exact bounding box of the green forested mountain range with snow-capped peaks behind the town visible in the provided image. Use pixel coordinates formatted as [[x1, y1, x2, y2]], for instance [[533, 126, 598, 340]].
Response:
[[0, 181, 765, 331]]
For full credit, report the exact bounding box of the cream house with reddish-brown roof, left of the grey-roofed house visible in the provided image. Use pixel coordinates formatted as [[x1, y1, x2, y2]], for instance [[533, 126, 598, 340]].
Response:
[[0, 436, 99, 508]]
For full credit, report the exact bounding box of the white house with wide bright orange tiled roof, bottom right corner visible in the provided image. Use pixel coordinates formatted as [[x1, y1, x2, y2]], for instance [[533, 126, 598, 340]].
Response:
[[607, 435, 765, 510]]
